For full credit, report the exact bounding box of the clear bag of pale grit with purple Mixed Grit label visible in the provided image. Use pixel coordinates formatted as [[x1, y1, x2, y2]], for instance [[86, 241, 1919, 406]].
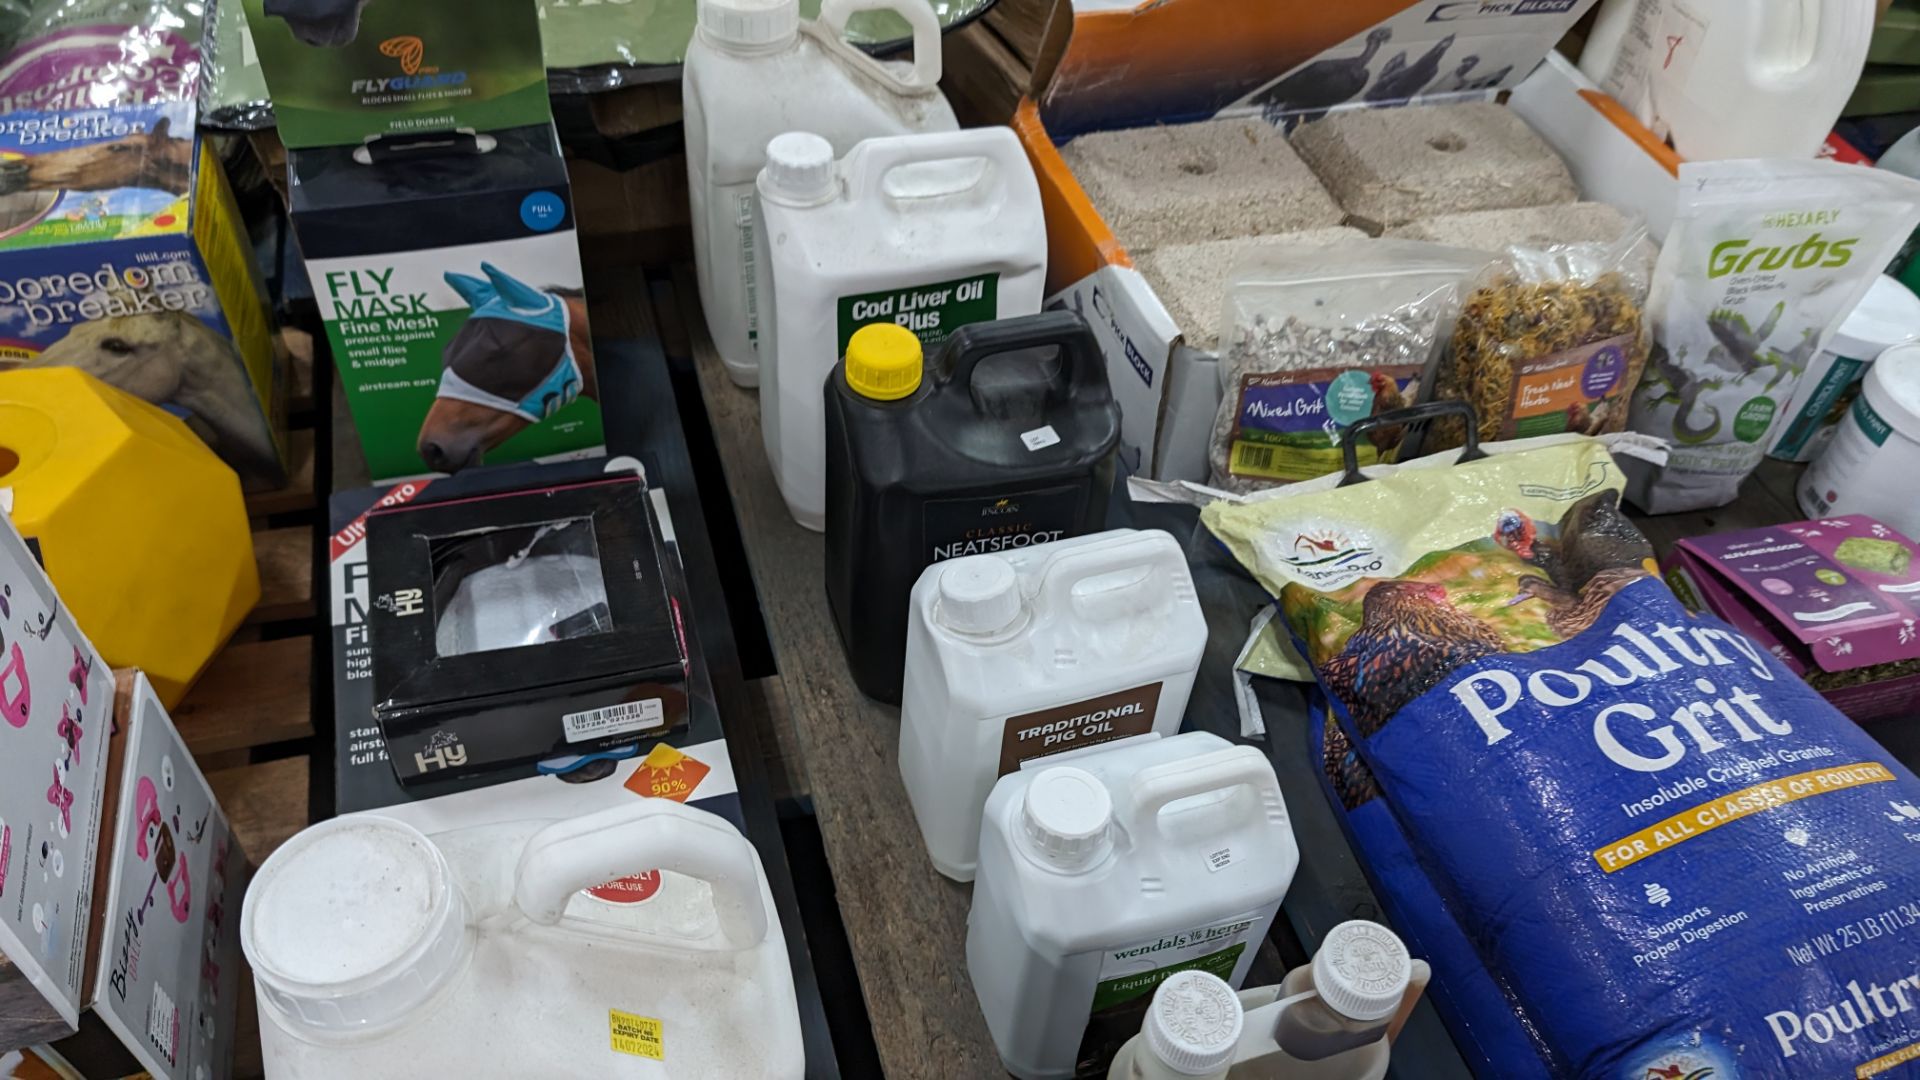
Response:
[[1212, 240, 1486, 492]]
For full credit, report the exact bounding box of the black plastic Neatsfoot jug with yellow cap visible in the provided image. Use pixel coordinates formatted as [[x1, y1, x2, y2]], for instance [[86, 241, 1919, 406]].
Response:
[[826, 311, 1119, 703]]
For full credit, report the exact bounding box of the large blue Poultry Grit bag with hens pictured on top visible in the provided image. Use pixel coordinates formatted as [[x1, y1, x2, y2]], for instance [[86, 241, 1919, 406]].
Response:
[[1202, 436, 1920, 1080]]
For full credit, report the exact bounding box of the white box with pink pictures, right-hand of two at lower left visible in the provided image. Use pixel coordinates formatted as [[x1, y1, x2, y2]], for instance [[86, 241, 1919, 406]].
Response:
[[54, 671, 248, 1080]]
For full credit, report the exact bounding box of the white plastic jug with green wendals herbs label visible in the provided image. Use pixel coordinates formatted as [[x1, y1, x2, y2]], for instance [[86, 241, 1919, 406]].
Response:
[[966, 732, 1300, 1080]]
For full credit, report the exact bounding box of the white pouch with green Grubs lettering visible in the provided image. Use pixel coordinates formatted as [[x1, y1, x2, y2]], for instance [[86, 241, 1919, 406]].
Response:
[[1626, 161, 1920, 513]]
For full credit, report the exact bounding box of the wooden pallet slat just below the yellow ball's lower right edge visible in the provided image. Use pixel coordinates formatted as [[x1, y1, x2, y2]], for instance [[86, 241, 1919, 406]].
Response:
[[173, 638, 313, 757]]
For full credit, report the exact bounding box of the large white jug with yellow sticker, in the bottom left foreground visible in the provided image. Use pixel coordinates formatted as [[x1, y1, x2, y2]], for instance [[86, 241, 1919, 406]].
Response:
[[240, 798, 804, 1080]]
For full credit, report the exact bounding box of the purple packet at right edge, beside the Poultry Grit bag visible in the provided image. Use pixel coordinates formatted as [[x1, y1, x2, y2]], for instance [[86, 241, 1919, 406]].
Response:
[[1663, 513, 1920, 723]]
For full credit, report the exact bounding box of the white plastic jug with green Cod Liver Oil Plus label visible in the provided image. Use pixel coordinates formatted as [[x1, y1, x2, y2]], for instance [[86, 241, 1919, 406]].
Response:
[[756, 127, 1046, 532]]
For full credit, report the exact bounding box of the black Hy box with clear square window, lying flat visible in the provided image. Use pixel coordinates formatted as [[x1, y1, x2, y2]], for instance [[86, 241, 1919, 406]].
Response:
[[367, 465, 687, 784]]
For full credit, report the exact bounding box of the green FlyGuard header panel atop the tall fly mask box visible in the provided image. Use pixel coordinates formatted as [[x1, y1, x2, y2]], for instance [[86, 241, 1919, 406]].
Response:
[[242, 0, 549, 146]]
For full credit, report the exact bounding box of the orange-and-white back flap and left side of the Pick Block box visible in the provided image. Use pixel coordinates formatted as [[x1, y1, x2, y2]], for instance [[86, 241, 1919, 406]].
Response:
[[1014, 0, 1592, 480]]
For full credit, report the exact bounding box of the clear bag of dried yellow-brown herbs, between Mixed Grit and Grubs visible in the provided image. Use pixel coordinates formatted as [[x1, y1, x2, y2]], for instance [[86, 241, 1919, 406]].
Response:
[[1423, 227, 1651, 450]]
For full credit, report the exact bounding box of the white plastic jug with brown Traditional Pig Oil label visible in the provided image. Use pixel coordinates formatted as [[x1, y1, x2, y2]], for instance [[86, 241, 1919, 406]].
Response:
[[900, 521, 1206, 882]]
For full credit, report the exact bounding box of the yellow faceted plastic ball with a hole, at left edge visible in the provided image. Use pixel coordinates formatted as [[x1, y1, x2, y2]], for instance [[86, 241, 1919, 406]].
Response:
[[0, 367, 259, 707]]
